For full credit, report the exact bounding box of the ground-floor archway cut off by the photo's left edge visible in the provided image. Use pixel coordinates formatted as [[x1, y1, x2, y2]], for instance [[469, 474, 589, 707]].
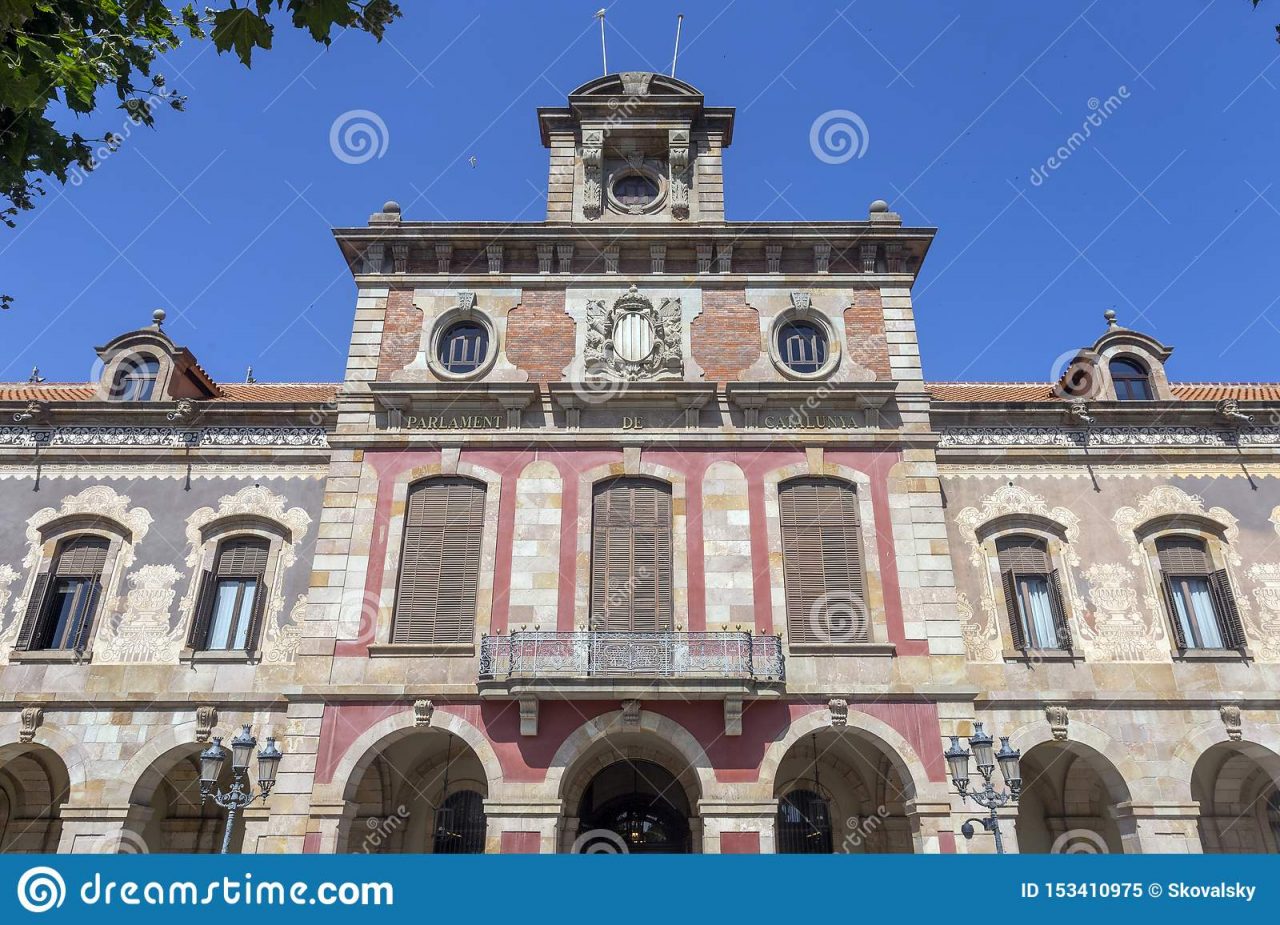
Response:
[[0, 746, 70, 855]]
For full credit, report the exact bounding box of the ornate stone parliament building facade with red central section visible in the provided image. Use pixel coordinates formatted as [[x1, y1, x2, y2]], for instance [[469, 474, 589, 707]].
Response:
[[0, 73, 1280, 853]]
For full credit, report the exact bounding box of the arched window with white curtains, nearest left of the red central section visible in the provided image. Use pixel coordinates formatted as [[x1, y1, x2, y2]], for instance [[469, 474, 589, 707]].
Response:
[[188, 536, 271, 651]]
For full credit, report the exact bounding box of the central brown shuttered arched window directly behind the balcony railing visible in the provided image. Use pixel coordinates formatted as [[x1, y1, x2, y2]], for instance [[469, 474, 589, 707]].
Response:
[[591, 478, 675, 632]]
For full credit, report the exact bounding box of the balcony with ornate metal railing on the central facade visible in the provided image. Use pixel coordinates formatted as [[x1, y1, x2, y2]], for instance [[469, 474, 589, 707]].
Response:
[[479, 631, 786, 697]]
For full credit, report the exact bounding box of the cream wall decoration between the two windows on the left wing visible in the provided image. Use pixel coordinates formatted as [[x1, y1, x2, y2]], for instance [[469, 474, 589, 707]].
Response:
[[93, 565, 183, 664]]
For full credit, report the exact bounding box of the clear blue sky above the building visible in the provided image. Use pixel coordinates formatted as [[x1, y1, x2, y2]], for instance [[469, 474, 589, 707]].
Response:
[[0, 0, 1280, 381]]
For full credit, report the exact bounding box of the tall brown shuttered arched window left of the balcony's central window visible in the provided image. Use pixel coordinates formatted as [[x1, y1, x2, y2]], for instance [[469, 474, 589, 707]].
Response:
[[392, 477, 485, 645]]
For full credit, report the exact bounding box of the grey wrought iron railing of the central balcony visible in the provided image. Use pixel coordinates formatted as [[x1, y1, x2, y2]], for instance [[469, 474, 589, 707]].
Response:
[[480, 629, 785, 681]]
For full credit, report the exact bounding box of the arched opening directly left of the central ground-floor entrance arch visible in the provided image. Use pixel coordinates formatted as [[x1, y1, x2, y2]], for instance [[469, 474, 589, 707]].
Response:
[[344, 729, 489, 855]]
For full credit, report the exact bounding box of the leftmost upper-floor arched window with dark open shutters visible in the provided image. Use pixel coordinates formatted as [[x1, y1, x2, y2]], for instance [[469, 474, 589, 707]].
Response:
[[17, 535, 110, 651]]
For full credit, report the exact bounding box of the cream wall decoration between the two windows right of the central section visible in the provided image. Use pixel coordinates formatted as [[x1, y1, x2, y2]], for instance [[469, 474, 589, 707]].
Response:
[[1080, 563, 1169, 661]]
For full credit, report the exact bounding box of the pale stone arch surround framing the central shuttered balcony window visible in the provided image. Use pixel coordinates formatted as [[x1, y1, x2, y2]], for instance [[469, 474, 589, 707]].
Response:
[[573, 457, 689, 627]]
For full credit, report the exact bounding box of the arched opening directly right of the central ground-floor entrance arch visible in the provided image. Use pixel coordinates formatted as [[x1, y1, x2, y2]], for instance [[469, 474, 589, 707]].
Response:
[[773, 727, 914, 855]]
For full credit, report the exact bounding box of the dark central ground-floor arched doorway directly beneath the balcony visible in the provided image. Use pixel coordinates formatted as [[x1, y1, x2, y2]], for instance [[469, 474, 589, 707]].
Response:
[[575, 759, 692, 855]]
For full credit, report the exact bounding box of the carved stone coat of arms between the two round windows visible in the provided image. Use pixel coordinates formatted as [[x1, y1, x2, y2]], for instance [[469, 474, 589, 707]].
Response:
[[584, 285, 685, 381]]
